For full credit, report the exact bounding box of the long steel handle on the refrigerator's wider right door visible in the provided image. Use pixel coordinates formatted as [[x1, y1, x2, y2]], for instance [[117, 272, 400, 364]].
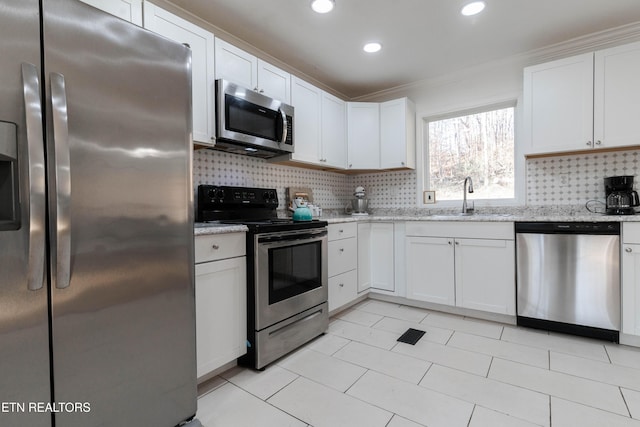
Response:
[[50, 73, 71, 289]]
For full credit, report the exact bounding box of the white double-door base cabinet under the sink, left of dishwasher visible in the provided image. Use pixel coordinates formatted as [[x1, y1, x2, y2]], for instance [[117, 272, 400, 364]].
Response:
[[406, 222, 516, 315]]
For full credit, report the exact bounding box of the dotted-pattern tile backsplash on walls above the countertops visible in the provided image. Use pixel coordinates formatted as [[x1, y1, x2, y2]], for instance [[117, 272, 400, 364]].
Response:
[[193, 149, 640, 209]]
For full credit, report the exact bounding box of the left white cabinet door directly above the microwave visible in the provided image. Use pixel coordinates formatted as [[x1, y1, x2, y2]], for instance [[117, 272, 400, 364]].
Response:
[[215, 37, 258, 90]]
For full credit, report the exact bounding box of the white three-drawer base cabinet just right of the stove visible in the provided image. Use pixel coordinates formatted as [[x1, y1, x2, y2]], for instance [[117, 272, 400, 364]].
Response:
[[328, 222, 358, 312]]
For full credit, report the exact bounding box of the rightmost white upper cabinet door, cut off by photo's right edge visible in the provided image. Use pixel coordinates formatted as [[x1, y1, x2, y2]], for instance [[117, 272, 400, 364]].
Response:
[[593, 43, 640, 147]]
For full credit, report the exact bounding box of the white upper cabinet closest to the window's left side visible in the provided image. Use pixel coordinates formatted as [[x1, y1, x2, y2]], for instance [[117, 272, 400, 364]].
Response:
[[380, 98, 416, 169]]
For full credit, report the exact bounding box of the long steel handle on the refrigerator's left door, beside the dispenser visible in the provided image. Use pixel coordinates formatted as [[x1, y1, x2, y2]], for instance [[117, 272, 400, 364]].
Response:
[[22, 63, 46, 291]]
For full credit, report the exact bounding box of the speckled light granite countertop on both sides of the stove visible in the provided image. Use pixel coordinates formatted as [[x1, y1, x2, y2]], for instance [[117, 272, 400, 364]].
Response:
[[195, 205, 640, 236]]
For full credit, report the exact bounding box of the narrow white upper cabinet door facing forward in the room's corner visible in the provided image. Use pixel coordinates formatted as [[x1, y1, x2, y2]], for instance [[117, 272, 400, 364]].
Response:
[[347, 102, 380, 169]]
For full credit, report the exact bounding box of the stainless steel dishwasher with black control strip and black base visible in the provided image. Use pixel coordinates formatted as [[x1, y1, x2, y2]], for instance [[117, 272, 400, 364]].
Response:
[[515, 222, 620, 342]]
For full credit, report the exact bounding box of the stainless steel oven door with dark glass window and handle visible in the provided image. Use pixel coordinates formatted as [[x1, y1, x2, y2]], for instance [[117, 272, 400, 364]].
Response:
[[255, 228, 328, 331]]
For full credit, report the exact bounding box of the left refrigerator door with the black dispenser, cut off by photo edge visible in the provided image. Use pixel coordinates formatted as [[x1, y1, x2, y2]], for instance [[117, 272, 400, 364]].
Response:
[[0, 0, 51, 427]]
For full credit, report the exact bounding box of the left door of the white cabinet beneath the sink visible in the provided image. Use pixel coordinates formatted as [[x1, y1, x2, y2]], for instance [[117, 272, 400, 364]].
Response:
[[406, 237, 456, 306]]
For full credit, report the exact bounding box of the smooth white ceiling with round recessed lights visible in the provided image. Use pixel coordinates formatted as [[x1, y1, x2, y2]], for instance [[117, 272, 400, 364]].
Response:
[[171, 0, 640, 99]]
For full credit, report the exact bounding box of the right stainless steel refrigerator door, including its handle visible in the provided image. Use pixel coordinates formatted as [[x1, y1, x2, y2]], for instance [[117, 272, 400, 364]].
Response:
[[43, 0, 196, 427]]
